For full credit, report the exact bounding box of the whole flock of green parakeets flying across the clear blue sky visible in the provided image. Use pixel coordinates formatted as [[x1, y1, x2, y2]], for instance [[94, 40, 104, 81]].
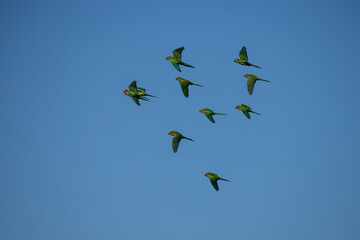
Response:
[[123, 47, 270, 191]]
